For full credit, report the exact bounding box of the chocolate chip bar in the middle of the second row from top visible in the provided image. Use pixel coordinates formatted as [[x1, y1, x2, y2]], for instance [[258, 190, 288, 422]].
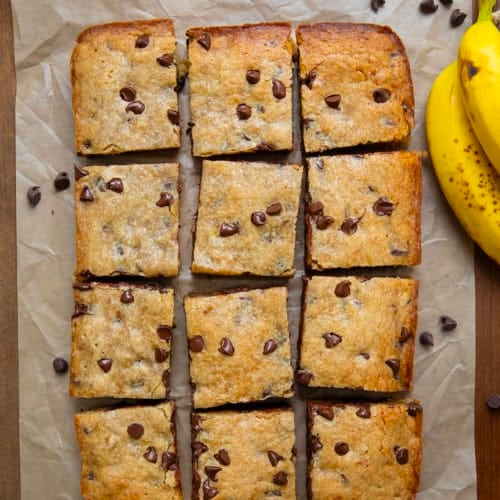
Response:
[[191, 160, 302, 277]]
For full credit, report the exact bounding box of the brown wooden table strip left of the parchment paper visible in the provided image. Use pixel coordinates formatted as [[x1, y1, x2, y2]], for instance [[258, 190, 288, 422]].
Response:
[[0, 0, 20, 500]]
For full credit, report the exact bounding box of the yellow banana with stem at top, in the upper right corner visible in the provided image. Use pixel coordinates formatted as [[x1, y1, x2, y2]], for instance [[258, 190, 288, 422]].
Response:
[[458, 0, 500, 172]]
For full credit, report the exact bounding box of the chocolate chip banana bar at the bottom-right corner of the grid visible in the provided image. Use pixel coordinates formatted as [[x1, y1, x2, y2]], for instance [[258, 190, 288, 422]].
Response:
[[308, 401, 423, 500]]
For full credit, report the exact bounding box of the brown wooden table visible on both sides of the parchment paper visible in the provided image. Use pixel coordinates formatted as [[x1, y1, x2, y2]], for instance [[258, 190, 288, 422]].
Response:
[[0, 0, 500, 500]]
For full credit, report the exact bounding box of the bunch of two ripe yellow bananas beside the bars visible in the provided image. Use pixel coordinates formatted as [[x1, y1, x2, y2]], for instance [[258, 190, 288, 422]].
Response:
[[426, 0, 500, 264]]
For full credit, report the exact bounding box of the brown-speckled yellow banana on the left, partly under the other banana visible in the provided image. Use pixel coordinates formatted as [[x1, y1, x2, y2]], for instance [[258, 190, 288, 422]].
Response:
[[426, 62, 500, 264]]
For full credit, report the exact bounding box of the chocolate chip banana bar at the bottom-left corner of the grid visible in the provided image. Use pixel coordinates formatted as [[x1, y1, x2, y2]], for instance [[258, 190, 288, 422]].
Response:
[[74, 402, 182, 500]]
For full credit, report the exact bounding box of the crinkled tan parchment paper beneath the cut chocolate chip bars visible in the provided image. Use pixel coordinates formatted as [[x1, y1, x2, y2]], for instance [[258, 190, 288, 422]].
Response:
[[13, 0, 476, 500]]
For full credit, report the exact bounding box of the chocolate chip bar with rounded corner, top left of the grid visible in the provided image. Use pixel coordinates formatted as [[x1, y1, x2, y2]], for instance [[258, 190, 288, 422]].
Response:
[[71, 19, 181, 155]]
